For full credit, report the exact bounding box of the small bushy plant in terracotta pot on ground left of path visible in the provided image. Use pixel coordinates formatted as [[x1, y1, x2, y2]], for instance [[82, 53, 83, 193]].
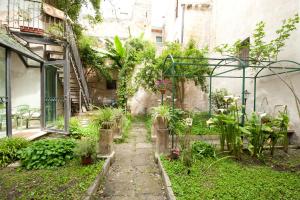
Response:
[[74, 138, 96, 165]]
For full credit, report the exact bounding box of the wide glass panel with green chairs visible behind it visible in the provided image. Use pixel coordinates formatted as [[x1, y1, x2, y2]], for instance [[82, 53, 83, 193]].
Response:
[[10, 53, 41, 137]]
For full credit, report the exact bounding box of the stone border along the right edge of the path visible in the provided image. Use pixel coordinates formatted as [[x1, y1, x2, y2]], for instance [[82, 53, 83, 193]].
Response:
[[155, 153, 176, 200]]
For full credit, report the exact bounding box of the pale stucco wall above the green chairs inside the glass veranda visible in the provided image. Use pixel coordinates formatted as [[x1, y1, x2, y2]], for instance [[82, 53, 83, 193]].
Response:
[[11, 53, 41, 112]]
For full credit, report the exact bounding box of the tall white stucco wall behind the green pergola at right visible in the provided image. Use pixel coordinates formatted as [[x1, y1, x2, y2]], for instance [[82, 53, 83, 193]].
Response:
[[210, 0, 300, 141]]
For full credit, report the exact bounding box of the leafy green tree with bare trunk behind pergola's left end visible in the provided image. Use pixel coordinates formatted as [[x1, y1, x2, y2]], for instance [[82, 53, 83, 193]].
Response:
[[137, 40, 210, 108]]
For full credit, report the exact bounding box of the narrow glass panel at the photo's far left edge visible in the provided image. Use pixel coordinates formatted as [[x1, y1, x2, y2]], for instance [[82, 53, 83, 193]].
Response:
[[0, 47, 7, 138]]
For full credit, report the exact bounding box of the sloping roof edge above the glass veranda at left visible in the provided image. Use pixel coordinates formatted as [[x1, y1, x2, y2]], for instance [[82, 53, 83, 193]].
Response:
[[0, 30, 44, 63]]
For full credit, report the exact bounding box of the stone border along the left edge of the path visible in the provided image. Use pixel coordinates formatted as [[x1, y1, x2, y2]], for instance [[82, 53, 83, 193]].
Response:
[[84, 151, 115, 200]]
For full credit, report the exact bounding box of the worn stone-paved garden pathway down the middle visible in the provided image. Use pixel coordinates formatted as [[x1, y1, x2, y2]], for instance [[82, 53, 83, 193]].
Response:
[[95, 123, 166, 200]]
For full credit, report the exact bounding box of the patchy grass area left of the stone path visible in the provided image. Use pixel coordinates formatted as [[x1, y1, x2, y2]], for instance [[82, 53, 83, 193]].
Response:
[[0, 160, 104, 199]]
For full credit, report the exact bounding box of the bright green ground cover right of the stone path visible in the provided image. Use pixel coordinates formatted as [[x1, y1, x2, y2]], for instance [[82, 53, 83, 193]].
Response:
[[162, 149, 300, 200]]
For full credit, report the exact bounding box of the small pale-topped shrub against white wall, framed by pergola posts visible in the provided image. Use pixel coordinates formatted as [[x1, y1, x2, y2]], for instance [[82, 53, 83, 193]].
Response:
[[211, 88, 228, 111]]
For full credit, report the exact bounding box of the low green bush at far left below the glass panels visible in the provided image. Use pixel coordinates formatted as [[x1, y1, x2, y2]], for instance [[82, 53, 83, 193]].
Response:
[[0, 138, 29, 167]]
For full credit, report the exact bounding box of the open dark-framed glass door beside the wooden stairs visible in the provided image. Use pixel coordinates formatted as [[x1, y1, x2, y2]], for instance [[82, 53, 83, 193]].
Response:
[[45, 66, 65, 131]]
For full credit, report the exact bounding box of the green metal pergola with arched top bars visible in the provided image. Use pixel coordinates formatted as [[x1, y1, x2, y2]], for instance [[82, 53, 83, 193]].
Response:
[[161, 55, 300, 148]]
